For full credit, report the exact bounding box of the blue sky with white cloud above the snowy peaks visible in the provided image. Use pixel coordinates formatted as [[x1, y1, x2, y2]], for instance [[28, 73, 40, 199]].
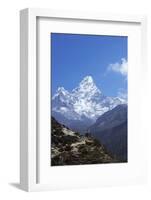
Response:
[[50, 33, 128, 96]]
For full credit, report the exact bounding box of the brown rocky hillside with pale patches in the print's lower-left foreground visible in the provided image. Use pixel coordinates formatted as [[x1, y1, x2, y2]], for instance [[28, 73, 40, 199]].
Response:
[[51, 117, 118, 166]]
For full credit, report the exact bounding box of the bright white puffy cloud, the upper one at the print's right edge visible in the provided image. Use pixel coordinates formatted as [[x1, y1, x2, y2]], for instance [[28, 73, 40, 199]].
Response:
[[107, 58, 128, 76]]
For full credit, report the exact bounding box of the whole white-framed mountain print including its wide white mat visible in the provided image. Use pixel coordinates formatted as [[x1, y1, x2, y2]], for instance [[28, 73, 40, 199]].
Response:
[[20, 9, 147, 191]]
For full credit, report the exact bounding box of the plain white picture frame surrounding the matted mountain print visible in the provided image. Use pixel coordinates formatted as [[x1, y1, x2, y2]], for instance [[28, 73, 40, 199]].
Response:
[[20, 8, 147, 191]]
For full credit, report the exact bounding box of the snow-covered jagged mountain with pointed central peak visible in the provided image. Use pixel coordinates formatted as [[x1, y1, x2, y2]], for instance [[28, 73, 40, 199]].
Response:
[[52, 76, 126, 132]]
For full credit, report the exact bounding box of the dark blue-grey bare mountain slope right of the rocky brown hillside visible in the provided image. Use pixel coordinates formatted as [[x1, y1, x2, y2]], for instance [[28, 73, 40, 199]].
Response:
[[88, 104, 127, 162]]
